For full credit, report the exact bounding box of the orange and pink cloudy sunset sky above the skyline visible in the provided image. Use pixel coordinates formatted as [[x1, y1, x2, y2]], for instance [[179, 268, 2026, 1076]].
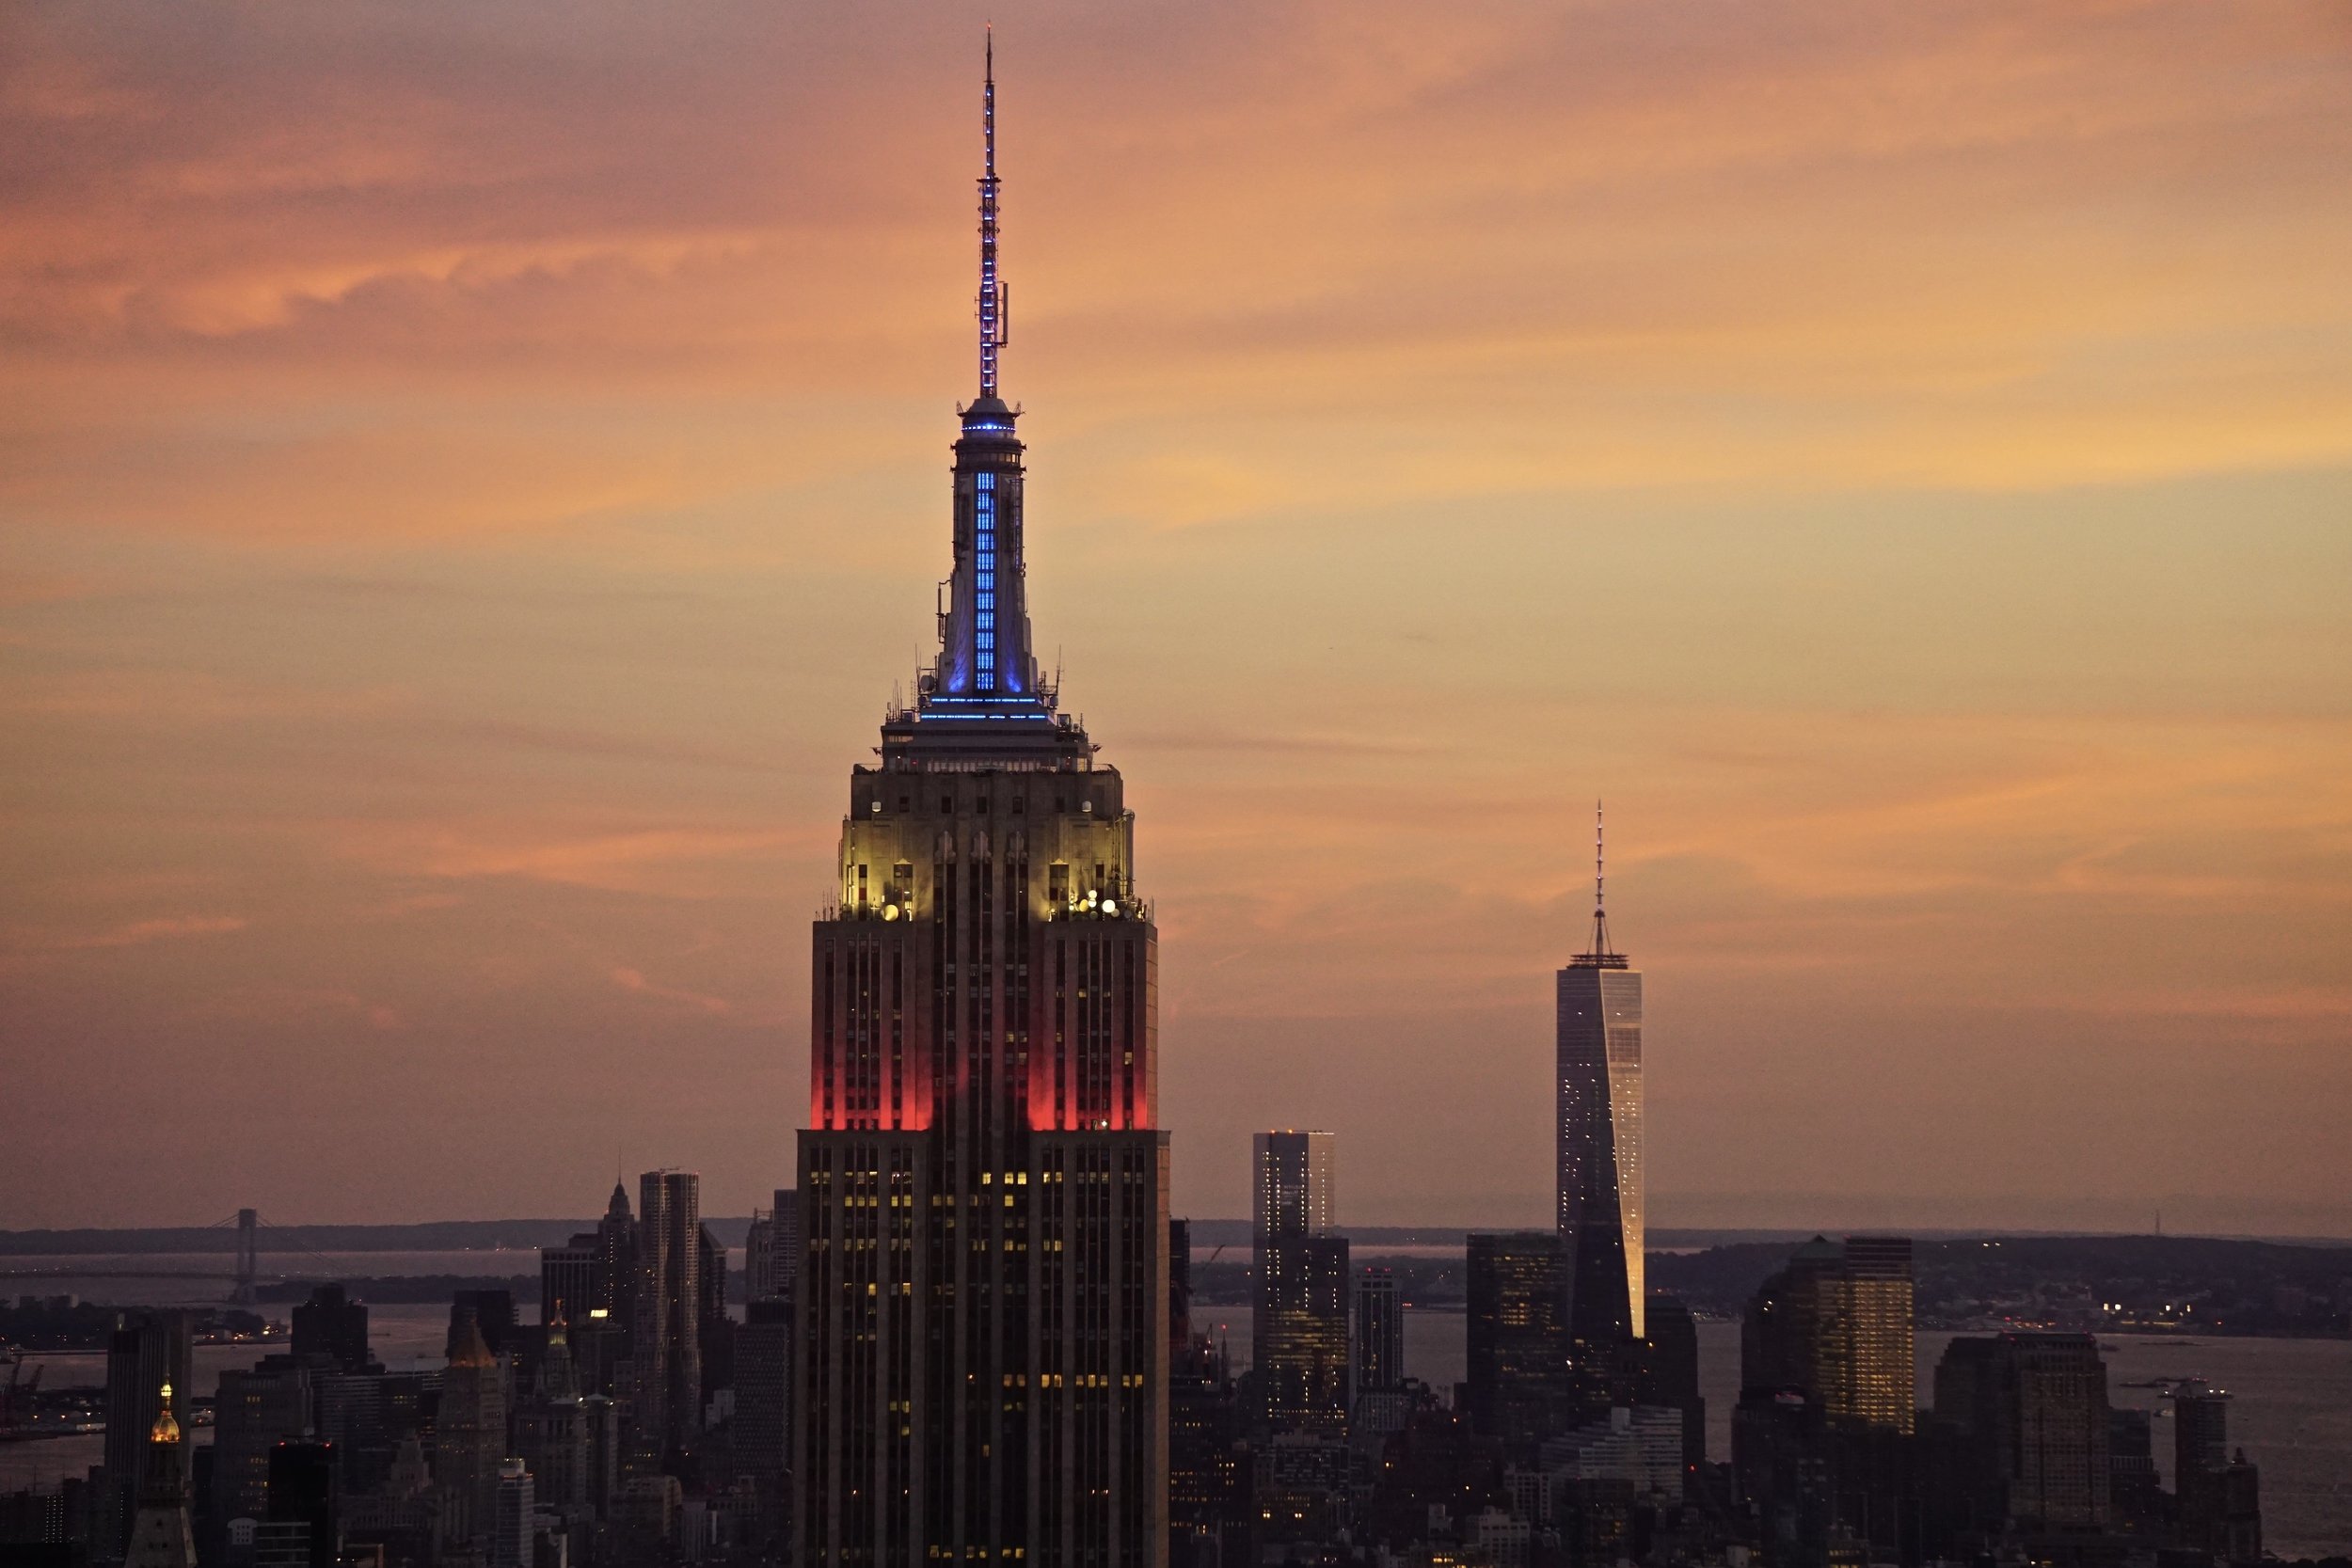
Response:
[[0, 0, 2352, 1237]]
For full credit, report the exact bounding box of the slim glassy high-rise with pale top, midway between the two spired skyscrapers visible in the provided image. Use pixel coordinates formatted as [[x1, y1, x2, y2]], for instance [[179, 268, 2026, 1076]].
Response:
[[1249, 1131, 1350, 1434]]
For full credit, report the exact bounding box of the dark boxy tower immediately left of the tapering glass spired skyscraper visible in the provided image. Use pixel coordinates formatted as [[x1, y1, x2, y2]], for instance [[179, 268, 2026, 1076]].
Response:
[[1468, 1229, 1576, 1449]]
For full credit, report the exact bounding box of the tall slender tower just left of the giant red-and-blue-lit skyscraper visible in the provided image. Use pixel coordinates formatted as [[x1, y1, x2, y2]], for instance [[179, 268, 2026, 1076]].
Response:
[[630, 1171, 708, 1474]]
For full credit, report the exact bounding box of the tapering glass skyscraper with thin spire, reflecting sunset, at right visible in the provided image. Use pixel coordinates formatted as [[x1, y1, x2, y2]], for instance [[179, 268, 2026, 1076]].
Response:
[[1557, 808, 1645, 1364]]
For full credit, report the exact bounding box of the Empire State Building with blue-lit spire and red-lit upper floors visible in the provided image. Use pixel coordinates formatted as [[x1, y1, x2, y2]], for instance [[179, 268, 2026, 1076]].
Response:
[[793, 46, 1169, 1568]]
